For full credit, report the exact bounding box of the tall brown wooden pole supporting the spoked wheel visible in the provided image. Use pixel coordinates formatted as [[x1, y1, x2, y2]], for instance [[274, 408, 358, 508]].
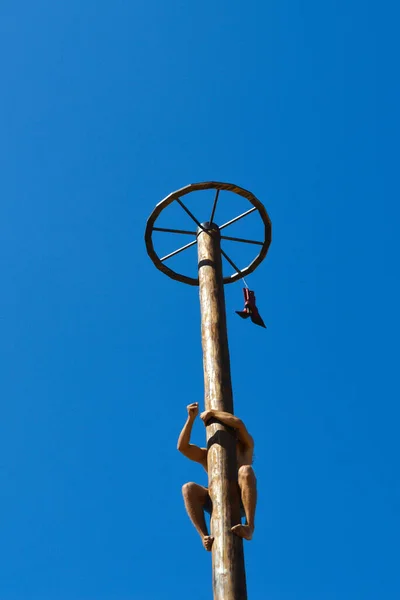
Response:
[[197, 223, 247, 600]]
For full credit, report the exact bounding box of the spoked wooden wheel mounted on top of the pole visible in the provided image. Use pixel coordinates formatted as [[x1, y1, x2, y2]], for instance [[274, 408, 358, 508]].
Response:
[[145, 181, 271, 285]]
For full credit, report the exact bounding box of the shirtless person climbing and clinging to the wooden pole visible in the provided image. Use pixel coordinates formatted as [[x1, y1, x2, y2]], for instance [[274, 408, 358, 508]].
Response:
[[178, 402, 257, 551]]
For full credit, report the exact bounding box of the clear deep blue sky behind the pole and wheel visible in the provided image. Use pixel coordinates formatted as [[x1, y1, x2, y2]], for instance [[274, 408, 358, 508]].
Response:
[[0, 0, 400, 600]]
